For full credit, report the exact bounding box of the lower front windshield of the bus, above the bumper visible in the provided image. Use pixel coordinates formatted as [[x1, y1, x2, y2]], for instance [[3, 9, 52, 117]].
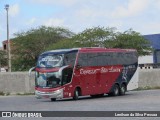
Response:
[[36, 72, 61, 88]]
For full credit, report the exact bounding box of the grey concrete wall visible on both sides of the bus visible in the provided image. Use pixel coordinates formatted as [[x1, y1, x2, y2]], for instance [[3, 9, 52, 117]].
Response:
[[0, 69, 160, 94]]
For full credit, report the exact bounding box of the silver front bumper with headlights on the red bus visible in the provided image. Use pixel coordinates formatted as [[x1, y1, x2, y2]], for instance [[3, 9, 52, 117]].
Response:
[[35, 89, 63, 99]]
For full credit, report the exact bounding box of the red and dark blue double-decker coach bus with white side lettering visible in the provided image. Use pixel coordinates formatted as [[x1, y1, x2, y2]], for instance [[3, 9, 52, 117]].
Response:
[[35, 48, 138, 101]]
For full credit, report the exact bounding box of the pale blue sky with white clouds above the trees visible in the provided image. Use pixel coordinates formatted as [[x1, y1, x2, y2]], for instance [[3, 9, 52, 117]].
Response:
[[0, 0, 160, 46]]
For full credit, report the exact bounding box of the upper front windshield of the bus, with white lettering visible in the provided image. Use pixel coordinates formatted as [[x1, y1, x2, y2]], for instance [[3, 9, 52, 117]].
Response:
[[37, 54, 64, 68]]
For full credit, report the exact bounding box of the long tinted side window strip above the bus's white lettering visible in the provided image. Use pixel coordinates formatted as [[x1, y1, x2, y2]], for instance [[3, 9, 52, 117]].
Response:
[[78, 52, 137, 66]]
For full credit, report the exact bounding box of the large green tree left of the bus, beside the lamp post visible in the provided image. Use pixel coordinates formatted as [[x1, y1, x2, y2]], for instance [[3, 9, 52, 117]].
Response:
[[12, 26, 74, 71]]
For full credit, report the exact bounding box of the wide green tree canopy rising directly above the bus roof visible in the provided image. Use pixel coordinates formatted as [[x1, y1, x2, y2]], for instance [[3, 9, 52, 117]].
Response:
[[49, 27, 152, 56]]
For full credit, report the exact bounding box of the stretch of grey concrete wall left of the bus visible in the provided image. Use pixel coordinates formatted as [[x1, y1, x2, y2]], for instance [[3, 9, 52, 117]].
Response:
[[0, 72, 34, 93]]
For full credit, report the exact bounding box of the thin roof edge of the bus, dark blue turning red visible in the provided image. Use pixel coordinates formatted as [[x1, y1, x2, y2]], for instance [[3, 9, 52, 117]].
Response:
[[41, 47, 136, 55]]
